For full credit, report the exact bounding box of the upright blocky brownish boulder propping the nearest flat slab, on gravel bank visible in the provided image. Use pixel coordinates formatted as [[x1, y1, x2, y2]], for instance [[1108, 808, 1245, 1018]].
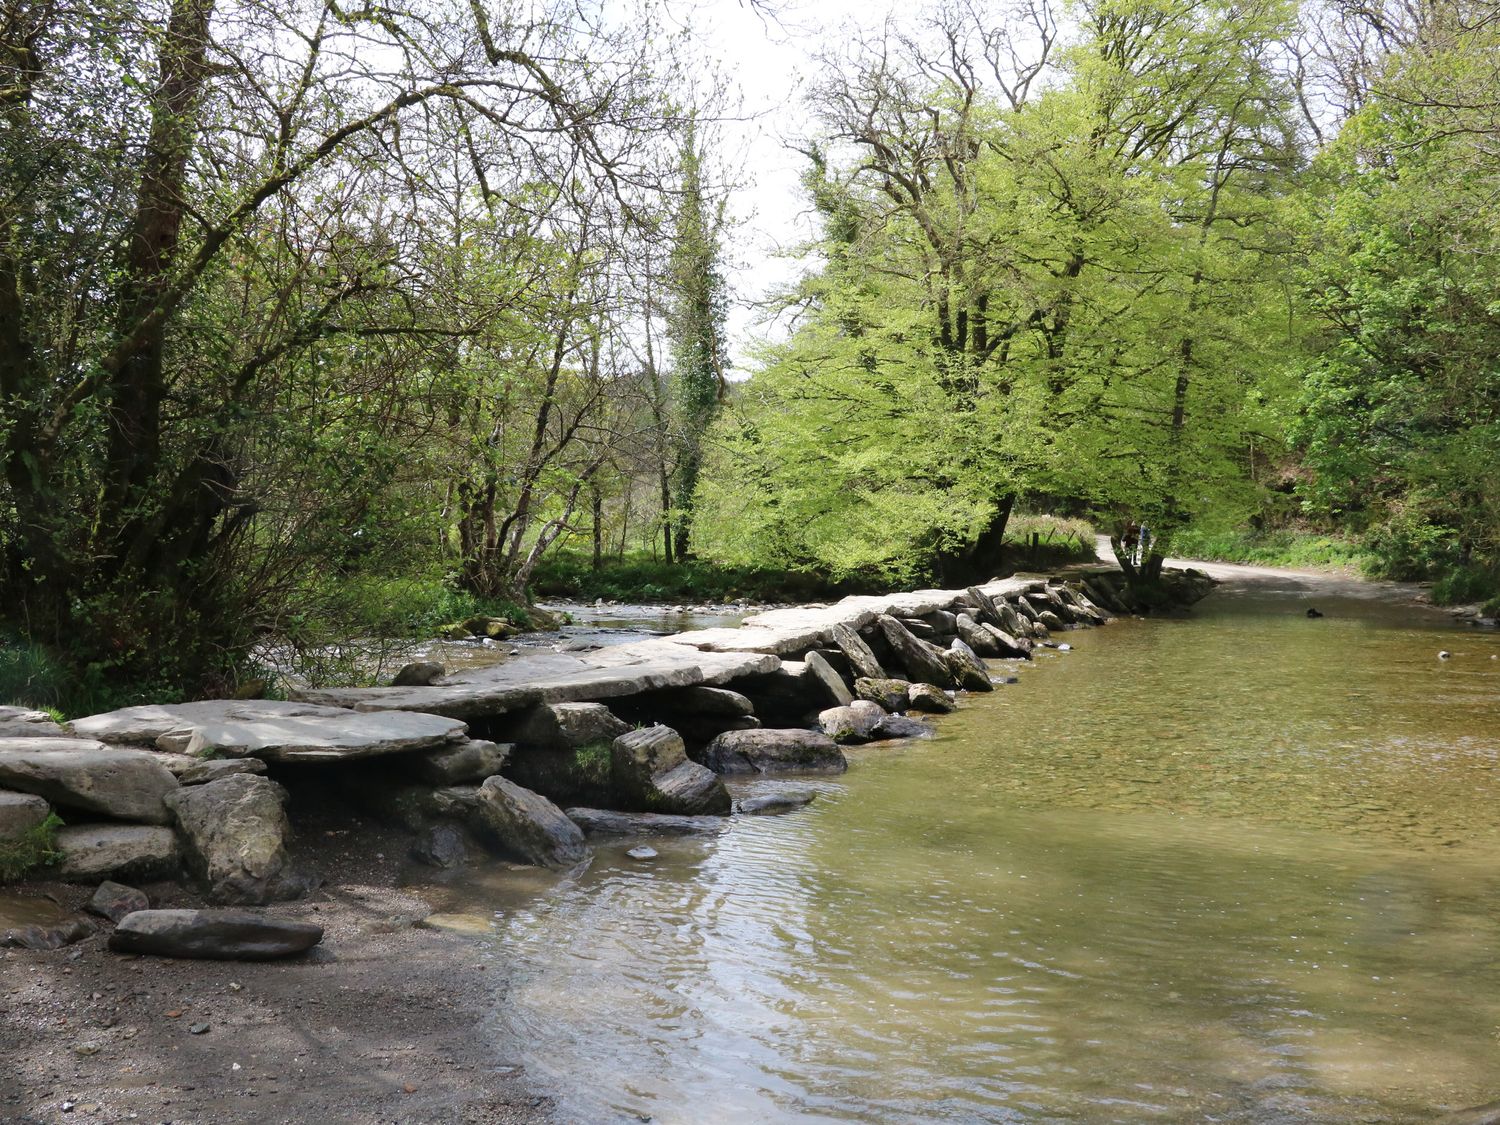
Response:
[[168, 774, 295, 906]]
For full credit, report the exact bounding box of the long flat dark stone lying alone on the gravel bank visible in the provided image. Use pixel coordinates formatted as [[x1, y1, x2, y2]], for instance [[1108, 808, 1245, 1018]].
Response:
[[110, 911, 323, 962]]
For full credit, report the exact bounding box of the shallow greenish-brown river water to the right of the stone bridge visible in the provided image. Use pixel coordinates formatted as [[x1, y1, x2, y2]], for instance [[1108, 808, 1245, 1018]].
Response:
[[429, 579, 1500, 1122]]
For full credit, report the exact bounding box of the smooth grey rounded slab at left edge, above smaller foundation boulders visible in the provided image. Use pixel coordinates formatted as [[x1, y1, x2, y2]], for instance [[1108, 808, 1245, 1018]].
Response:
[[0, 738, 177, 824]]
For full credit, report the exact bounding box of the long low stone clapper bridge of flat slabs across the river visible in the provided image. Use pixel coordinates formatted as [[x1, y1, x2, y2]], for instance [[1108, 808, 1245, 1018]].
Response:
[[0, 572, 1214, 956]]
